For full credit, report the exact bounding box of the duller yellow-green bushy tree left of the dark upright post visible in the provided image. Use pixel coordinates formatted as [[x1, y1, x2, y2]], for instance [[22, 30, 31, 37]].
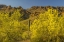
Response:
[[0, 10, 28, 42]]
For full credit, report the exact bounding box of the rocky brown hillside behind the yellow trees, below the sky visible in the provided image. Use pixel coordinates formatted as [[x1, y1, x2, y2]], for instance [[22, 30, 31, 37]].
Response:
[[0, 5, 64, 19]]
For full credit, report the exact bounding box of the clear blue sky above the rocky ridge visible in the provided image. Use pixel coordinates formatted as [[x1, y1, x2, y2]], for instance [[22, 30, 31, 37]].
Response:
[[0, 0, 64, 9]]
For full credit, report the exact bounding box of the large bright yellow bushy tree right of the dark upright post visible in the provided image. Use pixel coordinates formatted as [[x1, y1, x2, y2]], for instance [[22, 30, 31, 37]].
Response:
[[30, 9, 60, 42]]
